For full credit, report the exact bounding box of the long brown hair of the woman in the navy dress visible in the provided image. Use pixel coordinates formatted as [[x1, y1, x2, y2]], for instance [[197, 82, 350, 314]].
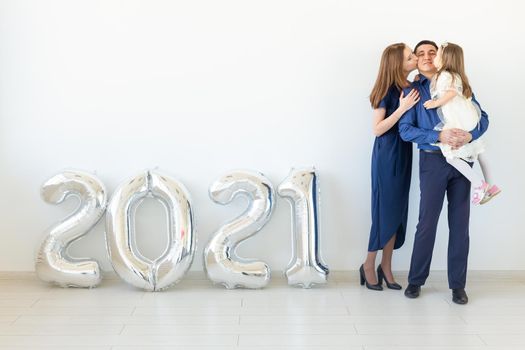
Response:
[[370, 43, 408, 108]]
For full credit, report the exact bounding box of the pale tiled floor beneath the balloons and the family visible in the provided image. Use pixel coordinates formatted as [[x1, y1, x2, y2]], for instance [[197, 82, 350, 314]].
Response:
[[0, 271, 525, 350]]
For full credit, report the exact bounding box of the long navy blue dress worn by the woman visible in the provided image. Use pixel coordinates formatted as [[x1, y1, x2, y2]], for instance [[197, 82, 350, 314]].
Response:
[[368, 86, 412, 251]]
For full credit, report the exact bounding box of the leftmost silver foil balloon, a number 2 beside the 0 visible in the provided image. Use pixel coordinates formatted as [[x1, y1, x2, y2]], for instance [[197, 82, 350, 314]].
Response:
[[35, 170, 107, 288]]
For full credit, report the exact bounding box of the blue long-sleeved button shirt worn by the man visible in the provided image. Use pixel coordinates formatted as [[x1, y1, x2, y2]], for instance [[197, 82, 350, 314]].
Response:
[[399, 74, 489, 150]]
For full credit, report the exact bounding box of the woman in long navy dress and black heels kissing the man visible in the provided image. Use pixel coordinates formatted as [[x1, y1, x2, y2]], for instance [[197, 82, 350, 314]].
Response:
[[359, 43, 419, 290]]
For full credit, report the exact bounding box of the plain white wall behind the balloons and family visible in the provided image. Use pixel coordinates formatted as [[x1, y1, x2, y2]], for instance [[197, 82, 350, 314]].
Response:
[[0, 0, 525, 271]]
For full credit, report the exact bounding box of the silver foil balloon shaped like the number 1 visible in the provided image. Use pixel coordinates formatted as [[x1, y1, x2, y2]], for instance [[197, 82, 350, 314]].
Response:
[[277, 167, 328, 288]]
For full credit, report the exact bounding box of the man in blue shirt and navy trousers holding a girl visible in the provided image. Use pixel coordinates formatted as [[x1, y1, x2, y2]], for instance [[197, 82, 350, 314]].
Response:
[[399, 40, 489, 304]]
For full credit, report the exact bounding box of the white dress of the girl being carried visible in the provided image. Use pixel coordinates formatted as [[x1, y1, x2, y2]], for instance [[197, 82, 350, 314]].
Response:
[[430, 71, 485, 162]]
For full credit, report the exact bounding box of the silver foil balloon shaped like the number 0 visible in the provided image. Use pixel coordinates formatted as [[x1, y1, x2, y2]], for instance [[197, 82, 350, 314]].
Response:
[[106, 170, 195, 291]]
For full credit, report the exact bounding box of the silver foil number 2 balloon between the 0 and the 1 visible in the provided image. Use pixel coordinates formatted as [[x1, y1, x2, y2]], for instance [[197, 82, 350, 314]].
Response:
[[204, 171, 275, 289]]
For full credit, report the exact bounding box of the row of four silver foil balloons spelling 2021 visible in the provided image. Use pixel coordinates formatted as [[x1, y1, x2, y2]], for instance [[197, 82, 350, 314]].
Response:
[[35, 168, 329, 291]]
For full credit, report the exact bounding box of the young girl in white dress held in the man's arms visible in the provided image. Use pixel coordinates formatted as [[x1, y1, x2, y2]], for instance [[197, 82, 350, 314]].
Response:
[[424, 43, 501, 204]]
